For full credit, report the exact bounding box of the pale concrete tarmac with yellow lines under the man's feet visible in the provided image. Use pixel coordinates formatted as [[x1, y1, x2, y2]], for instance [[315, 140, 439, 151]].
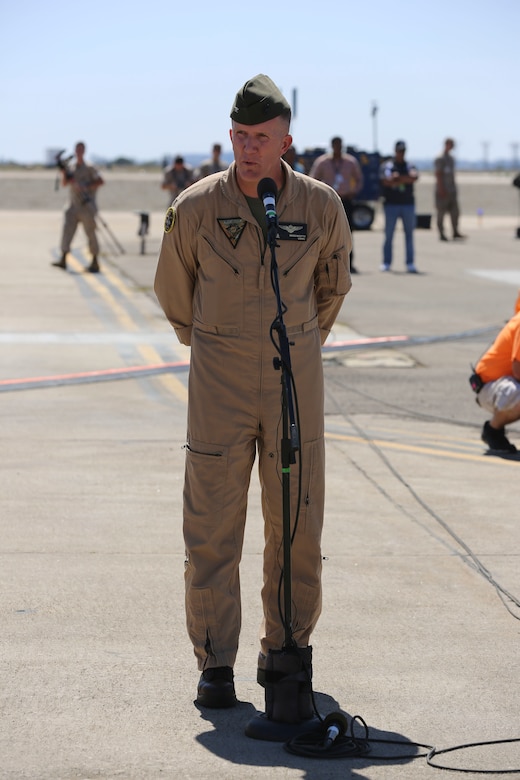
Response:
[[0, 198, 520, 780]]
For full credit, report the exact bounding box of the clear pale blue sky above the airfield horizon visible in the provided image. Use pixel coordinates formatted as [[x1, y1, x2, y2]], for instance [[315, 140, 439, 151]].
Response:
[[4, 0, 520, 163]]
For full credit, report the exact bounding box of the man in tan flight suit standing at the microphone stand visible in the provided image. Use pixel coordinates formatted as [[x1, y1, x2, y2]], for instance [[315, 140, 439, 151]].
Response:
[[155, 75, 351, 722]]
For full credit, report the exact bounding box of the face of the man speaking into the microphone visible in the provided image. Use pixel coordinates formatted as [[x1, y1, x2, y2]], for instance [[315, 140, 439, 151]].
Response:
[[229, 117, 292, 194]]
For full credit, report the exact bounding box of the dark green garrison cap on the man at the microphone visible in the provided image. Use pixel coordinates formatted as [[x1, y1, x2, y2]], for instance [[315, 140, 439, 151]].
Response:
[[230, 73, 291, 125]]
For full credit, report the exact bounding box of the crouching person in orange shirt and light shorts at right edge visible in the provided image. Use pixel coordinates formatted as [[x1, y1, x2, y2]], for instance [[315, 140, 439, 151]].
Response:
[[475, 294, 520, 453]]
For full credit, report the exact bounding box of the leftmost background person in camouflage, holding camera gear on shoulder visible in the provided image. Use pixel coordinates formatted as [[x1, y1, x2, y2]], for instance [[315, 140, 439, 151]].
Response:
[[52, 141, 104, 273]]
